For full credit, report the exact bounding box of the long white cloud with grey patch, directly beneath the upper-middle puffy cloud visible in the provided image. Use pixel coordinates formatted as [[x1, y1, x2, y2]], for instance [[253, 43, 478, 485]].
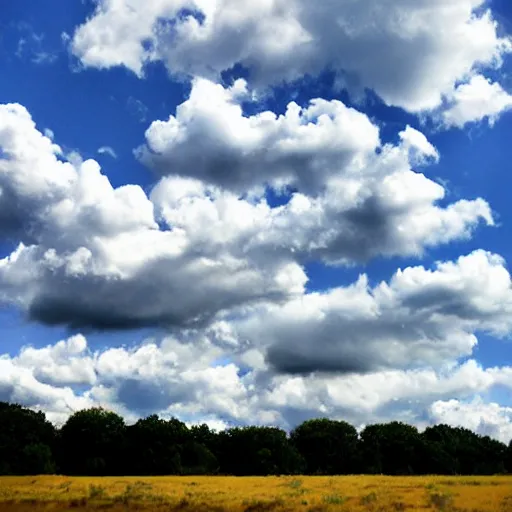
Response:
[[151, 171, 493, 264]]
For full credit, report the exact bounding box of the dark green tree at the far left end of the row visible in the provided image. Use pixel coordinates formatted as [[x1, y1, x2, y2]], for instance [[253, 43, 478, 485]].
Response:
[[0, 402, 55, 475]]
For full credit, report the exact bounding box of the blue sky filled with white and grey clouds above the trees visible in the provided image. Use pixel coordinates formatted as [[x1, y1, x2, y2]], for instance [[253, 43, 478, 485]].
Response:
[[0, 0, 512, 443]]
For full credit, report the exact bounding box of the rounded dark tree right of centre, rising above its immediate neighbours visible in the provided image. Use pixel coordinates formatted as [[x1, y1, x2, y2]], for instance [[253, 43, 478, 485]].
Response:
[[290, 418, 359, 474]]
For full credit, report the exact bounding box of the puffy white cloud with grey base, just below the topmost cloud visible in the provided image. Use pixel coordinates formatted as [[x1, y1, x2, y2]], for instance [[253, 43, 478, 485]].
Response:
[[138, 79, 380, 193]]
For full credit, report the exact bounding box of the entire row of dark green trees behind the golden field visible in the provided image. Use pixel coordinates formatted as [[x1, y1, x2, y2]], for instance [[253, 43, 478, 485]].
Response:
[[0, 402, 512, 476]]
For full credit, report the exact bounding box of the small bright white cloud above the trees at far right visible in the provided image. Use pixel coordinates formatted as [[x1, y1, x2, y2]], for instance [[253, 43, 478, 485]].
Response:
[[430, 397, 512, 444]]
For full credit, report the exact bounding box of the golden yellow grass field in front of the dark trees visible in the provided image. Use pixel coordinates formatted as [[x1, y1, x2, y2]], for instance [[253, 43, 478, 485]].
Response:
[[0, 476, 512, 512]]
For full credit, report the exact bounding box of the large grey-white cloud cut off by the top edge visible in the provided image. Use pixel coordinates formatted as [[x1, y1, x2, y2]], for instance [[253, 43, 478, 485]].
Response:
[[72, 0, 511, 111]]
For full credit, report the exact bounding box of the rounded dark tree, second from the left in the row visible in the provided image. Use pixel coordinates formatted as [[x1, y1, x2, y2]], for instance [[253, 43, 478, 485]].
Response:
[[58, 407, 126, 476]]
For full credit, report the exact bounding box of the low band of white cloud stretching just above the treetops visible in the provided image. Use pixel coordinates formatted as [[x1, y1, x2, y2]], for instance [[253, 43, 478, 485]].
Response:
[[0, 329, 512, 441]]
